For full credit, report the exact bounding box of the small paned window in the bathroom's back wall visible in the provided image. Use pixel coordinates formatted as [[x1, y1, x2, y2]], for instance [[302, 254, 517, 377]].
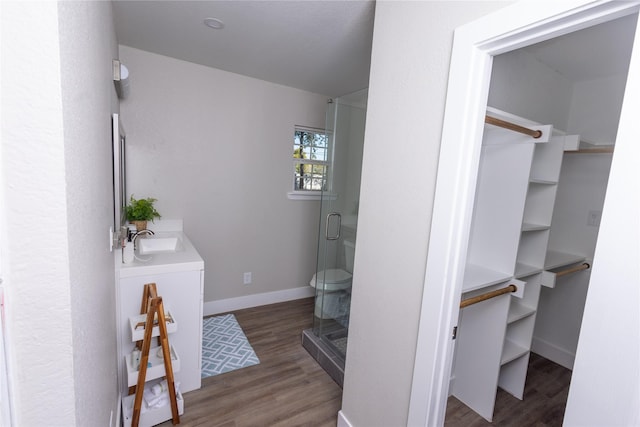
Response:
[[293, 126, 330, 193]]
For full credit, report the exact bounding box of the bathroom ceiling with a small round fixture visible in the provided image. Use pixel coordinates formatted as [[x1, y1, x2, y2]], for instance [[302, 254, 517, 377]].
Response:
[[113, 0, 375, 97]]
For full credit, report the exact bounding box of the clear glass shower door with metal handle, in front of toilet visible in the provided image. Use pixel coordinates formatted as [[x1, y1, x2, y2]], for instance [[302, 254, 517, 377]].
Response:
[[313, 90, 367, 362]]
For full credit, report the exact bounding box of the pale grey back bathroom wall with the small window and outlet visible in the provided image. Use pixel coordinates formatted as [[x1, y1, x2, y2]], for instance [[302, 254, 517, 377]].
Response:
[[120, 46, 327, 303]]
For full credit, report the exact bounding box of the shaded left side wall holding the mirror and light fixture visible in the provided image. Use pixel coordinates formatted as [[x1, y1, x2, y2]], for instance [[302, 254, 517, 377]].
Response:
[[58, 1, 118, 426]]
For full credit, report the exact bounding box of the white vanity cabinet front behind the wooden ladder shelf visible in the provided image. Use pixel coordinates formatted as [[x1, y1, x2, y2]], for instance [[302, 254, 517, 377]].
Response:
[[118, 270, 203, 393]]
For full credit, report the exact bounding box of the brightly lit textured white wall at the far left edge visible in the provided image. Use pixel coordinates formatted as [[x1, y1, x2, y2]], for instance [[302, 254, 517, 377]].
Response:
[[2, 3, 75, 425]]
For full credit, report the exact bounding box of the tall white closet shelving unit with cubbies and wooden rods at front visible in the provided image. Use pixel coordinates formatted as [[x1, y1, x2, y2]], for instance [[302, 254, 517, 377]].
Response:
[[451, 108, 564, 421]]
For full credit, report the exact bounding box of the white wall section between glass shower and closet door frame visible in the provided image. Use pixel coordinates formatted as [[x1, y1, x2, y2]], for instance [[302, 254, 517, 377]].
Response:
[[341, 1, 508, 426]]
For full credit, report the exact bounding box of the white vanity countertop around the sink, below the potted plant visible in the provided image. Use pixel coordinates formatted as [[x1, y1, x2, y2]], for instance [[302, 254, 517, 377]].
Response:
[[118, 231, 204, 278]]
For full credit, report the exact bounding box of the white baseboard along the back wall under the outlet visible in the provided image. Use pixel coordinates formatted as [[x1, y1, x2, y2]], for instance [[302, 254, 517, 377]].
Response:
[[202, 286, 314, 316]]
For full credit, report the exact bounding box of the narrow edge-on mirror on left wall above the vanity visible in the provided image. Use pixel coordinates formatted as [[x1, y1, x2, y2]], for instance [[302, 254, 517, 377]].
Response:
[[112, 114, 127, 248]]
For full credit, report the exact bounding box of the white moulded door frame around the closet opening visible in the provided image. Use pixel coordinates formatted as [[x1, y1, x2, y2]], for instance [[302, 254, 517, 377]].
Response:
[[407, 0, 640, 426]]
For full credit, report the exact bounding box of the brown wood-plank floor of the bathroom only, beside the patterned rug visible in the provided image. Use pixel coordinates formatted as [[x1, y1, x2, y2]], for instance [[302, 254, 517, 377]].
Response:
[[161, 298, 342, 427]]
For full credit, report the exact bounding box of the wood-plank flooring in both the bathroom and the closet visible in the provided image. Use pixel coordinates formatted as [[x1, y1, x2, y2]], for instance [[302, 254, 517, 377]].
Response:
[[161, 298, 571, 427]]
